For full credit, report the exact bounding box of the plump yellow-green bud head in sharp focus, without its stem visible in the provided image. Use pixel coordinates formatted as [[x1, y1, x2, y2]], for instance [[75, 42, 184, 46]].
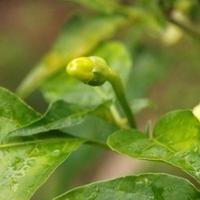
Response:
[[66, 56, 110, 86]]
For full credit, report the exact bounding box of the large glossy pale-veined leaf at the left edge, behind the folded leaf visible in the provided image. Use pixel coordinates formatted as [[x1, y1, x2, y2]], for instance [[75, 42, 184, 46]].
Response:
[[0, 88, 83, 200]]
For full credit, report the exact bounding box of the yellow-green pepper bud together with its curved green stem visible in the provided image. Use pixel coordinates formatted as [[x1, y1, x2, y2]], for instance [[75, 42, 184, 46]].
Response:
[[66, 56, 136, 128]]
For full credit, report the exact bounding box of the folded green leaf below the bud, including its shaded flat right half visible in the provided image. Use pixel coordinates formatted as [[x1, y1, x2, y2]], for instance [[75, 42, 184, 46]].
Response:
[[10, 100, 116, 144]]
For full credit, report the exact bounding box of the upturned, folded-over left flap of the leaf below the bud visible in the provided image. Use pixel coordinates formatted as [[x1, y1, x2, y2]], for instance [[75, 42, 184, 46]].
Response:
[[10, 100, 90, 137]]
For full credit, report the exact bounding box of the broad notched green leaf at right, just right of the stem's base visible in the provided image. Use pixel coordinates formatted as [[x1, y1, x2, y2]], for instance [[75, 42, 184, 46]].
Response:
[[108, 110, 200, 181]]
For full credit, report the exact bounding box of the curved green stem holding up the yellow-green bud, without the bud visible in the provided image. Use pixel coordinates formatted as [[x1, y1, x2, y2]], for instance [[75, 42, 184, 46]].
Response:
[[107, 71, 136, 128]]
